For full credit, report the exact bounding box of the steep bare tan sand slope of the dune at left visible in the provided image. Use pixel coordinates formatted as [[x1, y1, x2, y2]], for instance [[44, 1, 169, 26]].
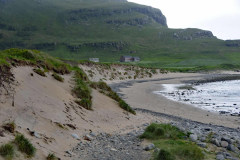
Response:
[[0, 67, 162, 160]]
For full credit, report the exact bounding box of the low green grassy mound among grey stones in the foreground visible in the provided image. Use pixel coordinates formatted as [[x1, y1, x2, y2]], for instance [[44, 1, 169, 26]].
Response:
[[140, 123, 204, 160]]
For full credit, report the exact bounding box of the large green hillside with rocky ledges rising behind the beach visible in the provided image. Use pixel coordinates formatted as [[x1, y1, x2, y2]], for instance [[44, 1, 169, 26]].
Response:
[[0, 0, 240, 67]]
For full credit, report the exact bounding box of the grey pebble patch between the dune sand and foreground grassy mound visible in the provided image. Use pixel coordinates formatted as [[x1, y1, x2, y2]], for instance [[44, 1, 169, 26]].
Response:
[[73, 132, 151, 160]]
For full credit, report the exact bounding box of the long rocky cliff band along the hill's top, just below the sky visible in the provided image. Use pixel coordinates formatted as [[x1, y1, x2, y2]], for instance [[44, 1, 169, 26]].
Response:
[[66, 7, 167, 27]]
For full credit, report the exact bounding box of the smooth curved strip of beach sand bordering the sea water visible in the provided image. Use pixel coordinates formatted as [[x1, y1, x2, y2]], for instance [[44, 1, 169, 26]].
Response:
[[110, 74, 240, 128]]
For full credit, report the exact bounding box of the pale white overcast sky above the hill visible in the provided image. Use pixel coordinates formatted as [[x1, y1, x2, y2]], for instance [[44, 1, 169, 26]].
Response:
[[128, 0, 240, 40]]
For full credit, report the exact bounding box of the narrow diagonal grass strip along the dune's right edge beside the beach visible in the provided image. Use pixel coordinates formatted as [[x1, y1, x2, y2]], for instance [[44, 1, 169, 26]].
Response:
[[90, 81, 136, 115]]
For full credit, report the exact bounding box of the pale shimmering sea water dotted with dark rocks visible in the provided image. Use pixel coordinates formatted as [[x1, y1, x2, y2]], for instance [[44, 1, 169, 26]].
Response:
[[154, 80, 240, 115]]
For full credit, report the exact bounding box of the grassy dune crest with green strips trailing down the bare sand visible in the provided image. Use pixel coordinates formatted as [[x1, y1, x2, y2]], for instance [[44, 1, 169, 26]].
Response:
[[0, 48, 135, 114]]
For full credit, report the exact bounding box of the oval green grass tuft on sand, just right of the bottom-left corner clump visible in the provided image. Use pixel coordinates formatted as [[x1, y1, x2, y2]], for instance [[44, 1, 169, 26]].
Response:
[[14, 134, 36, 157]]
